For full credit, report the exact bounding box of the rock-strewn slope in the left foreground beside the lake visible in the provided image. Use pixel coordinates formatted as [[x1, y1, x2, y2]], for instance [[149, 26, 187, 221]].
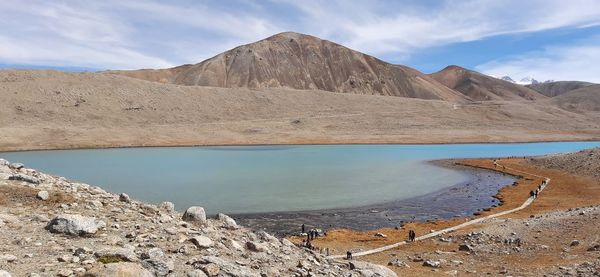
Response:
[[0, 159, 396, 277]]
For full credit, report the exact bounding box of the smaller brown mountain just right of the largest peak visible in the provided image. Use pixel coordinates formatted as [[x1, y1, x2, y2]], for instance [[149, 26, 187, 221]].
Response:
[[429, 65, 546, 101]]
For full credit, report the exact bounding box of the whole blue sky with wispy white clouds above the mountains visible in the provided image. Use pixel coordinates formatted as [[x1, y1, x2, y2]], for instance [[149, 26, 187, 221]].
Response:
[[0, 0, 600, 82]]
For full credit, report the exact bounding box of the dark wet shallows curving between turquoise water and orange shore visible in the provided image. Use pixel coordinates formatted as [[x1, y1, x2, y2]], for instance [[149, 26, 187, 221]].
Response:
[[231, 160, 517, 236]]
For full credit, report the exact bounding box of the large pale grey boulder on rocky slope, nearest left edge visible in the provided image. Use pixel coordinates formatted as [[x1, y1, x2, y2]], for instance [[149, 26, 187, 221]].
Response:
[[46, 214, 106, 236]]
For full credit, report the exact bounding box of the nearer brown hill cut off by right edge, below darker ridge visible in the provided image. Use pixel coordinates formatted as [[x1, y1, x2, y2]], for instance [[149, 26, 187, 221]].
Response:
[[550, 85, 600, 112]]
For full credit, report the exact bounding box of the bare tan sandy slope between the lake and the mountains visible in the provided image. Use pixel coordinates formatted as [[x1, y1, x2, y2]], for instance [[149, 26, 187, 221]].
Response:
[[0, 70, 600, 150]]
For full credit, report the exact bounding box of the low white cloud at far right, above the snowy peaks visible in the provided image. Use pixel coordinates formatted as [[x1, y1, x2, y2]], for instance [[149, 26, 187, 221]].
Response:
[[475, 38, 600, 83]]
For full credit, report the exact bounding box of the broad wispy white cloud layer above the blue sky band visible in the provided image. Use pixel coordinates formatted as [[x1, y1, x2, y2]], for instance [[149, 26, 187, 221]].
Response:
[[0, 0, 600, 69]]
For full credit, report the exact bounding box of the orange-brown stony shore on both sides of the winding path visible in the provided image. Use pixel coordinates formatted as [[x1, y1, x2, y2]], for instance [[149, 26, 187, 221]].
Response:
[[293, 158, 600, 276]]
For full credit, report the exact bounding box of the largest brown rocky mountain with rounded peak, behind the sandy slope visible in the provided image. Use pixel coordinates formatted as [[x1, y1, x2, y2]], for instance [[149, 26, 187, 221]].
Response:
[[110, 32, 466, 101]]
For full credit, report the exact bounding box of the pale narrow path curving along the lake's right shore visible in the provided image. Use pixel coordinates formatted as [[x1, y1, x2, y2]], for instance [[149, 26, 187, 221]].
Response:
[[327, 162, 550, 259]]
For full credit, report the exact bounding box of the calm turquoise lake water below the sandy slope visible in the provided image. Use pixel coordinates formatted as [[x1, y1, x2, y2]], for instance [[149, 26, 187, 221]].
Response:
[[0, 142, 600, 214]]
